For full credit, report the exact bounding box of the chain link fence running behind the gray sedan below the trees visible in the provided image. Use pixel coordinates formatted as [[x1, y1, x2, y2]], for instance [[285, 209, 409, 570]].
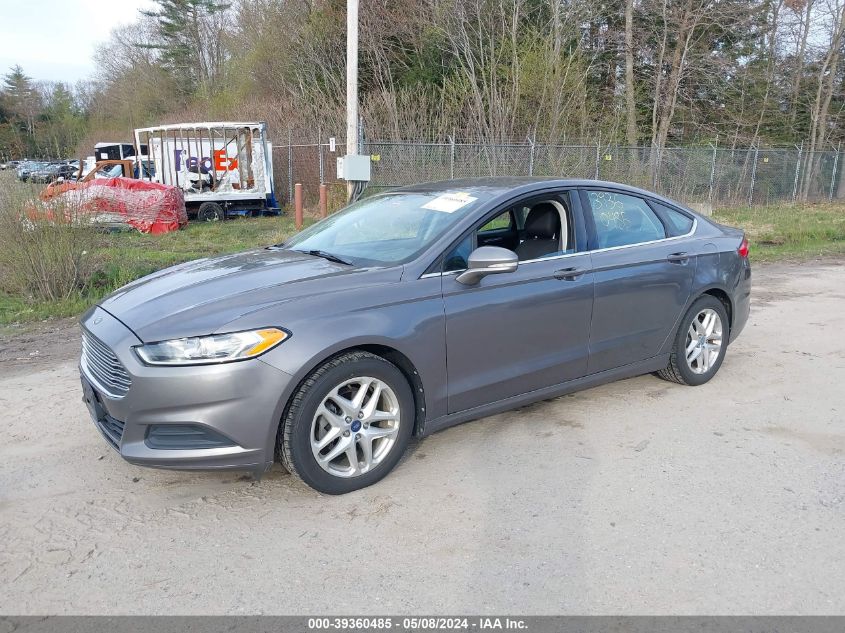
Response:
[[273, 139, 845, 210]]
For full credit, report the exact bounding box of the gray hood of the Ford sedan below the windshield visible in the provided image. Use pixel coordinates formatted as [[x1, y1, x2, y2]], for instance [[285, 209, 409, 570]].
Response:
[[99, 247, 402, 342]]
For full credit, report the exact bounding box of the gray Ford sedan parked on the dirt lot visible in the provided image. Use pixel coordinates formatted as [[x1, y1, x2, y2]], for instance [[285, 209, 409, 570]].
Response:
[[80, 178, 751, 494]]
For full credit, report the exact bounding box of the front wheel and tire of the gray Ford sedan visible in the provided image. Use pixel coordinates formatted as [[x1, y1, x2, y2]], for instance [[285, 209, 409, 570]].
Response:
[[278, 351, 416, 495]]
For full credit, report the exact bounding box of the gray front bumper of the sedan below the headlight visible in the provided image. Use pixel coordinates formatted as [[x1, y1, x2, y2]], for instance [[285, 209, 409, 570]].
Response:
[[79, 308, 291, 471]]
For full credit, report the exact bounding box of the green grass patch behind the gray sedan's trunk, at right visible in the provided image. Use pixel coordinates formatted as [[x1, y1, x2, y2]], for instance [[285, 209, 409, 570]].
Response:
[[713, 204, 845, 262]]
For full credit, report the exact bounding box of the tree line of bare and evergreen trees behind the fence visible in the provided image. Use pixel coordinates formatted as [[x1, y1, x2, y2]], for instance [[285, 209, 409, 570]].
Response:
[[0, 0, 845, 159]]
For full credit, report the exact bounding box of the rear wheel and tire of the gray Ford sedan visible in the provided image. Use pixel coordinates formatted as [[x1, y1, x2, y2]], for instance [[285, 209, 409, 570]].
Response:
[[657, 295, 730, 387]]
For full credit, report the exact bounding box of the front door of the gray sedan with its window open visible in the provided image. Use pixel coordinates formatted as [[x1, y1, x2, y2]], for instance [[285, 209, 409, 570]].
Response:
[[442, 193, 593, 413]]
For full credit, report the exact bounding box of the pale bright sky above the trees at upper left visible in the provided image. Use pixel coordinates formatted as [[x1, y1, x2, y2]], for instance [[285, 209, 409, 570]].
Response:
[[0, 0, 154, 83]]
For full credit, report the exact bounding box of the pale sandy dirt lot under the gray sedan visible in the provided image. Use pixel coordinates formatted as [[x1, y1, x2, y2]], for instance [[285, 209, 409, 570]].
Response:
[[0, 263, 845, 614]]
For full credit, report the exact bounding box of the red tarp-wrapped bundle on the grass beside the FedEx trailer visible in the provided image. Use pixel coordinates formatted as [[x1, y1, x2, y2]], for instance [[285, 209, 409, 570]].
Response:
[[39, 178, 188, 235]]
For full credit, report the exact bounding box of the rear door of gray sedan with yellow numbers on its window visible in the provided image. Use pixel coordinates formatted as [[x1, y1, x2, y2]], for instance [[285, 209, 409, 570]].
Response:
[[581, 189, 696, 374]]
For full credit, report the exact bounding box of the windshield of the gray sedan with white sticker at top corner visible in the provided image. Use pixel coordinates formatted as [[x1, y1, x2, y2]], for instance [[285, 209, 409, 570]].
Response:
[[283, 191, 479, 265]]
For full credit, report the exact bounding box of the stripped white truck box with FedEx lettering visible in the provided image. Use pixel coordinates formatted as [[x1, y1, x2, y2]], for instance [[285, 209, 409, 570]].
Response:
[[135, 121, 279, 222]]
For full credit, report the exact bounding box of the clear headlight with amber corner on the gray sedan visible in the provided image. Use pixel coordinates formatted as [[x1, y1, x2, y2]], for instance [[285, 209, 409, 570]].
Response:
[[135, 328, 290, 365]]
